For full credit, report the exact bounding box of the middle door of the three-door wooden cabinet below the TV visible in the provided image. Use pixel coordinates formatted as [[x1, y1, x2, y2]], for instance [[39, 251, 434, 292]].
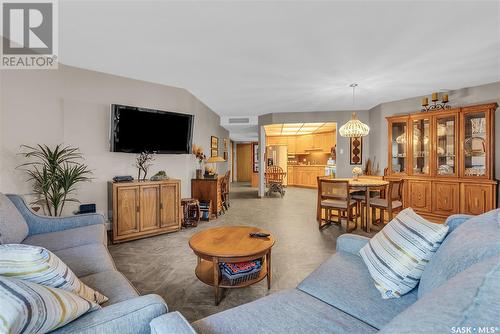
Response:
[[140, 185, 160, 232]]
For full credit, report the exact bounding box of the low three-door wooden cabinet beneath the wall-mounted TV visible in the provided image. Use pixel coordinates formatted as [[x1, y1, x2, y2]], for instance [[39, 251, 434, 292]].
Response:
[[108, 180, 181, 243]]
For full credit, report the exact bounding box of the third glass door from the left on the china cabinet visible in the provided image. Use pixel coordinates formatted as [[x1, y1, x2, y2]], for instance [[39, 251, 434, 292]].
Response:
[[436, 115, 457, 176]]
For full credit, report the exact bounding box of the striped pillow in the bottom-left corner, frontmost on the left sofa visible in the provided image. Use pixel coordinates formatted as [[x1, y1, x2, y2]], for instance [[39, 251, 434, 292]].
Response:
[[0, 276, 100, 334]]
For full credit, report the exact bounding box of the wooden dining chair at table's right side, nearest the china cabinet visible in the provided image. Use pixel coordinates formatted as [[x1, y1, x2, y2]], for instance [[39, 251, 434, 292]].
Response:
[[361, 179, 404, 225]]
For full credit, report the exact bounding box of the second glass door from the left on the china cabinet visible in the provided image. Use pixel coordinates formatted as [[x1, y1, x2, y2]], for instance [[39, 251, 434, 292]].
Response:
[[411, 118, 431, 175]]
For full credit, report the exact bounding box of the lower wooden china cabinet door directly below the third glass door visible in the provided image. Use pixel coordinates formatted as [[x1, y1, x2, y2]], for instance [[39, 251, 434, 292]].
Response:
[[432, 182, 459, 215]]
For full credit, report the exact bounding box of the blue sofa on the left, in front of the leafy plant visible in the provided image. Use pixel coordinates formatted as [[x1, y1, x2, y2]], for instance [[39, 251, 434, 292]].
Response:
[[0, 193, 168, 334]]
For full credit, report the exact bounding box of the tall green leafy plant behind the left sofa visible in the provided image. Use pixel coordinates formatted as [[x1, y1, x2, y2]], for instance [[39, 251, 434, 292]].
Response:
[[18, 145, 92, 216]]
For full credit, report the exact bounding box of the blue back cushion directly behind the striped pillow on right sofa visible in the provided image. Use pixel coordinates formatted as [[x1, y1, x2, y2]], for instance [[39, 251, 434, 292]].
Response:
[[418, 209, 500, 298]]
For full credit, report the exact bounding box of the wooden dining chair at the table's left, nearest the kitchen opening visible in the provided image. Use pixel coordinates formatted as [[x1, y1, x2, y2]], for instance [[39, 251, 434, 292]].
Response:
[[317, 177, 358, 232]]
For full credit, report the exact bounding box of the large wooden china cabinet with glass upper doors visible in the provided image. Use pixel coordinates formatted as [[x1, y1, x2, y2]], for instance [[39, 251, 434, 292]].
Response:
[[386, 103, 498, 222]]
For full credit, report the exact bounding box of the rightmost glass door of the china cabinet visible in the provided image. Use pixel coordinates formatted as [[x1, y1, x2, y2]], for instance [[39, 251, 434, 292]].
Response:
[[463, 112, 487, 176]]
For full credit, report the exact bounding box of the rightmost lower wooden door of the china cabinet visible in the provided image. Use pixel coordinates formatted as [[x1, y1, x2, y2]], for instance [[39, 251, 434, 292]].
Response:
[[460, 183, 493, 215]]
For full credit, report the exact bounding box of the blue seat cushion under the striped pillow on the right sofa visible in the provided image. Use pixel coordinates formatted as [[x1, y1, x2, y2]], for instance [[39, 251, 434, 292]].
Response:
[[298, 252, 417, 329]]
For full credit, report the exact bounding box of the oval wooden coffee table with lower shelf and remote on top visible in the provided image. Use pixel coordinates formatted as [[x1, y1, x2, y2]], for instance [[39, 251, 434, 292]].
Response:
[[189, 226, 274, 305]]
